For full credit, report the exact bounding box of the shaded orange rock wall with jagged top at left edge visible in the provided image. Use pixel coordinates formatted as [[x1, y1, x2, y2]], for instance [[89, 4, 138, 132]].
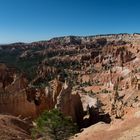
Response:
[[0, 64, 36, 117]]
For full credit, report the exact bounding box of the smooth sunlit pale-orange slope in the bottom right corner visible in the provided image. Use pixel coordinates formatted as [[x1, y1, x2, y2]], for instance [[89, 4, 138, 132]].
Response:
[[71, 109, 140, 140]]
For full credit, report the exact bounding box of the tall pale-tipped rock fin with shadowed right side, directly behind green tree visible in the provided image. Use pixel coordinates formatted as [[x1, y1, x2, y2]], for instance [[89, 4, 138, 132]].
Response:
[[55, 82, 84, 125]]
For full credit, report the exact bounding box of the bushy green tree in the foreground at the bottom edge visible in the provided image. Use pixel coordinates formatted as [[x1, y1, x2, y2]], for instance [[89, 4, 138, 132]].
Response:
[[32, 109, 78, 140]]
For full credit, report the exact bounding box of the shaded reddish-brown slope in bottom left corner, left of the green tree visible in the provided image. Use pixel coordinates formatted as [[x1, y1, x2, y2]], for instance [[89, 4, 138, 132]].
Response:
[[0, 115, 31, 140]]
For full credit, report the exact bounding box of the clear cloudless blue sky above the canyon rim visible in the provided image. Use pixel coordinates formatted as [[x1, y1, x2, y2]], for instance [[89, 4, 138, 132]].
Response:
[[0, 0, 140, 44]]
